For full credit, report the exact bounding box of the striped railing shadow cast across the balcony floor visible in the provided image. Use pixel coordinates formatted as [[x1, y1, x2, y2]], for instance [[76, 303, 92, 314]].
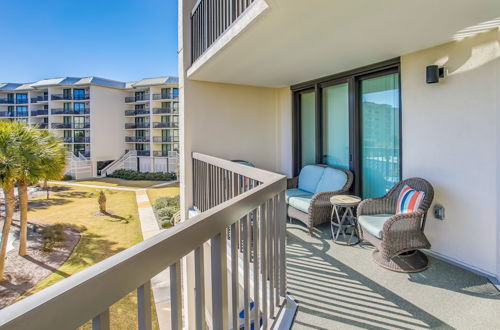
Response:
[[287, 227, 451, 329]]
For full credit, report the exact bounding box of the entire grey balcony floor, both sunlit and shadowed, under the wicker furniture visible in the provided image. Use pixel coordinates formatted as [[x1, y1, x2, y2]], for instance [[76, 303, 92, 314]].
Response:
[[287, 221, 500, 329]]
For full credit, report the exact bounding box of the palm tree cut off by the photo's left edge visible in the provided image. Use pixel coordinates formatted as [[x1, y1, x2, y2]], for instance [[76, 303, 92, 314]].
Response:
[[0, 122, 22, 280]]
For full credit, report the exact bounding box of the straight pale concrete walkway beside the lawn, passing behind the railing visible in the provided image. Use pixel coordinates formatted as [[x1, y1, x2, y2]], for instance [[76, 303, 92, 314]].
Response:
[[135, 189, 170, 330]]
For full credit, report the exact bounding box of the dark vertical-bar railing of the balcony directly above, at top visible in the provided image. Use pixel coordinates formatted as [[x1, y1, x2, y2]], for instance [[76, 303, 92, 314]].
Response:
[[191, 0, 254, 63]]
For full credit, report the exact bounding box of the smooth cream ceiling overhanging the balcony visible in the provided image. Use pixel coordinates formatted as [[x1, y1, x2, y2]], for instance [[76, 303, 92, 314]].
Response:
[[190, 0, 500, 87]]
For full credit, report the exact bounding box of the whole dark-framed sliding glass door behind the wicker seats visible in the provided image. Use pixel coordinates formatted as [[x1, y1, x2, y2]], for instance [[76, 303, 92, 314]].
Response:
[[292, 59, 401, 198]]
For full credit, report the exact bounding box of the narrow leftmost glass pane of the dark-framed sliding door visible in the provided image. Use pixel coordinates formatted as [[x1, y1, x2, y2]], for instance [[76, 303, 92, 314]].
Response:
[[300, 92, 316, 168]]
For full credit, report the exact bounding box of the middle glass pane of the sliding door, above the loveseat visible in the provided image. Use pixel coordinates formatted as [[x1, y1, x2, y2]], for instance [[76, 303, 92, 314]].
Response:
[[322, 83, 349, 169]]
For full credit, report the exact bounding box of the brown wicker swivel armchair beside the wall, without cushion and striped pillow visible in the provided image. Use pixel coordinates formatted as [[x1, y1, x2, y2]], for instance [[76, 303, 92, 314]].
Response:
[[357, 178, 434, 273]]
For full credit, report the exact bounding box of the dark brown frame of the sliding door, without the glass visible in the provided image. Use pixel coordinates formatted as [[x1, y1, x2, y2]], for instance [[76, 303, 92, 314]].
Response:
[[290, 57, 403, 196]]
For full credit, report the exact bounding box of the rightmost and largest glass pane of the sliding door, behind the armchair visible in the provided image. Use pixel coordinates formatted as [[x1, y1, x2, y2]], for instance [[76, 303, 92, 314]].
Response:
[[360, 73, 401, 198]]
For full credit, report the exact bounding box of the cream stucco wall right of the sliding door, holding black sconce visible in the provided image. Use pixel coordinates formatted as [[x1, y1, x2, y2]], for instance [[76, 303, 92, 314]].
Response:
[[401, 30, 500, 275]]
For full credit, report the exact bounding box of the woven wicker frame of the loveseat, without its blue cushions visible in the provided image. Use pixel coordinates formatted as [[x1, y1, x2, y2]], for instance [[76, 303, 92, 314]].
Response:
[[287, 164, 353, 235]]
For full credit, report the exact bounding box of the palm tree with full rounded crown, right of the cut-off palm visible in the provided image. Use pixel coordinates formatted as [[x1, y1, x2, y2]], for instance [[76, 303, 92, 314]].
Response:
[[17, 125, 66, 256]]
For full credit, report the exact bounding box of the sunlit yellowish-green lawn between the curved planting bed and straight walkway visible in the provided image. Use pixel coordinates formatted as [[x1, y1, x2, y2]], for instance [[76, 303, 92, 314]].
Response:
[[23, 186, 158, 329]]
